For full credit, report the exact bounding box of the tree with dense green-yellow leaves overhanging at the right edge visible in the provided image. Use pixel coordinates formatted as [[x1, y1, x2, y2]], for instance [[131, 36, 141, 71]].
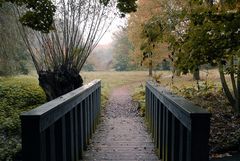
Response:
[[172, 1, 240, 113]]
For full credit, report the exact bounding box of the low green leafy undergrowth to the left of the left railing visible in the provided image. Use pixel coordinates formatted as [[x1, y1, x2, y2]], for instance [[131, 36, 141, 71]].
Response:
[[0, 76, 46, 161]]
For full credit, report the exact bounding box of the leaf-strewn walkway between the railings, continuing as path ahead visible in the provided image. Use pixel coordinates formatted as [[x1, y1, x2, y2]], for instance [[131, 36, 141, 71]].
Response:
[[83, 86, 158, 161]]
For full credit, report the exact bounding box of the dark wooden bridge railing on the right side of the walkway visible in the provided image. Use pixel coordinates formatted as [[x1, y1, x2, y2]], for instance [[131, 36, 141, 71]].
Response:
[[146, 81, 211, 161]]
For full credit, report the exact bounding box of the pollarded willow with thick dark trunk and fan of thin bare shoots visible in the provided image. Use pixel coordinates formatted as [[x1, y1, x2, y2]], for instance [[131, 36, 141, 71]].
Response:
[[18, 0, 135, 100]]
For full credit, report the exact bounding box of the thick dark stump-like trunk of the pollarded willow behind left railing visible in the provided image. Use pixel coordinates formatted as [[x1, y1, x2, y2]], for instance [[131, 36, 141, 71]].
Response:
[[38, 66, 83, 101]]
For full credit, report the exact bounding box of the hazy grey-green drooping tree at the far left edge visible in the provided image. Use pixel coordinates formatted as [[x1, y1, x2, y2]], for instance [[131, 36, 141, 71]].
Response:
[[0, 3, 30, 76]]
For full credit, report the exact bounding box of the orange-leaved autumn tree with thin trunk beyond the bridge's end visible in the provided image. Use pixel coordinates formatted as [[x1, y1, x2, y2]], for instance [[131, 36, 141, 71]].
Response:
[[128, 0, 169, 75]]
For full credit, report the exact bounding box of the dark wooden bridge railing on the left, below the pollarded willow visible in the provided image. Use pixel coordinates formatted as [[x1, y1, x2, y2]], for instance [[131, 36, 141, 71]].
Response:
[[20, 80, 101, 161]]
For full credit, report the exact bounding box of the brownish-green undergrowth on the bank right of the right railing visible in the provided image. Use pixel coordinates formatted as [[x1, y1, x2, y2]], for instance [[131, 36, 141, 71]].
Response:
[[174, 83, 240, 157]]
